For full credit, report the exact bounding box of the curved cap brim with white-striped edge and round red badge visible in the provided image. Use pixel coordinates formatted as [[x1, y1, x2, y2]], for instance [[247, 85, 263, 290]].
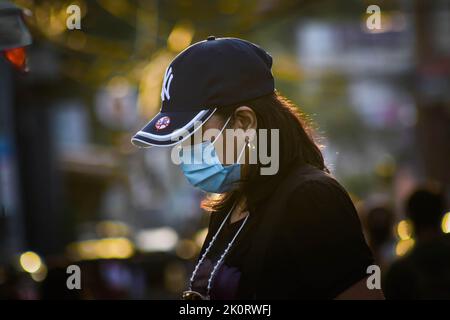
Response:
[[131, 109, 216, 148]]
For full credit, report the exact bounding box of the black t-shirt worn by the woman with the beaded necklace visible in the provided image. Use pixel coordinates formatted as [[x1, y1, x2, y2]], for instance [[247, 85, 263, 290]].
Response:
[[194, 167, 373, 299]]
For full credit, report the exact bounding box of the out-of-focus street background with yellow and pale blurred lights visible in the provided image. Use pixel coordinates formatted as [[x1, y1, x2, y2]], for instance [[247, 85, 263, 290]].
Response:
[[0, 0, 450, 299]]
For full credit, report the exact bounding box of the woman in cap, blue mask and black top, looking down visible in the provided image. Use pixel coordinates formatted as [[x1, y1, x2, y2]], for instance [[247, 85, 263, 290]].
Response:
[[132, 37, 383, 299]]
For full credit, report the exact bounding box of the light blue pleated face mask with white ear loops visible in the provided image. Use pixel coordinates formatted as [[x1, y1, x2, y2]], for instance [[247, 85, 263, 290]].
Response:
[[181, 119, 245, 193]]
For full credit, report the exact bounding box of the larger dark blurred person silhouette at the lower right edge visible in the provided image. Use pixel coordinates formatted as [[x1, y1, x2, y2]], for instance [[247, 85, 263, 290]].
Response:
[[384, 187, 450, 299]]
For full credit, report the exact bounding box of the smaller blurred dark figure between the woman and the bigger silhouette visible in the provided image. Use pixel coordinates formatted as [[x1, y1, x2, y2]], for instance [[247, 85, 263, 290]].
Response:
[[363, 205, 395, 270]]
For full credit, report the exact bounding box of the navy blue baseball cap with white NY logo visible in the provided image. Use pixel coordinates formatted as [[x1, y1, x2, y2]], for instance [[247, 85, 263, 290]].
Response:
[[131, 36, 275, 147]]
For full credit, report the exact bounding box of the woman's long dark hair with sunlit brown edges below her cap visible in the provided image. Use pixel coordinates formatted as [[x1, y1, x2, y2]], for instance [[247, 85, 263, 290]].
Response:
[[202, 92, 328, 211]]
